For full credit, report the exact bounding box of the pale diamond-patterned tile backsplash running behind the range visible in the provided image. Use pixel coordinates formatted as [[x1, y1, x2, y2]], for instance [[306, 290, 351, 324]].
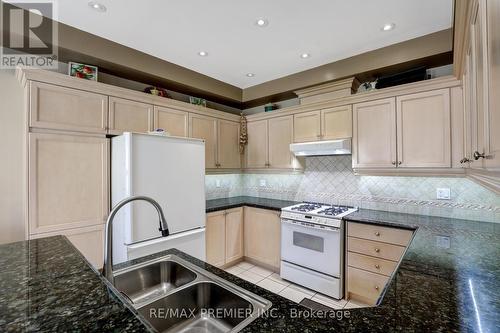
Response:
[[205, 156, 500, 222]]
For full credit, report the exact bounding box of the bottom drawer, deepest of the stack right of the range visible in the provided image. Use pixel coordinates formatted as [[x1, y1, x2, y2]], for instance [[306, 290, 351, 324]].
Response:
[[347, 267, 389, 304]]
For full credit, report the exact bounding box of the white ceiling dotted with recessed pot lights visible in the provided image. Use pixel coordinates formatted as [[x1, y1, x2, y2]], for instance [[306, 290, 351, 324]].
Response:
[[53, 0, 453, 88]]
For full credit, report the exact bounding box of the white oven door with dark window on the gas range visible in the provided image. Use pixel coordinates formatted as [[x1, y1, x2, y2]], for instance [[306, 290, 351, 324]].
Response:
[[281, 219, 343, 277]]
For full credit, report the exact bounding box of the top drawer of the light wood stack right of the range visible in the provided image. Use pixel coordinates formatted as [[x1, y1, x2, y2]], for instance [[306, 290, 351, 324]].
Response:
[[347, 222, 413, 246]]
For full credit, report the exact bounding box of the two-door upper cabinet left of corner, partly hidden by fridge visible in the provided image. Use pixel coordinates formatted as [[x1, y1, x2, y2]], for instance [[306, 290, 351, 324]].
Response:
[[189, 113, 241, 169]]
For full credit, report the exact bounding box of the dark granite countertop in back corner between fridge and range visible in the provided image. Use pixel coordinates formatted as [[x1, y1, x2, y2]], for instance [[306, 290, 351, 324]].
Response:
[[206, 196, 298, 213]]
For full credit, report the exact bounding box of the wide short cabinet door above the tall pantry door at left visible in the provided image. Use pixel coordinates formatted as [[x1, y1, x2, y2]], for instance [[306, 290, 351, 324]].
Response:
[[29, 81, 108, 133]]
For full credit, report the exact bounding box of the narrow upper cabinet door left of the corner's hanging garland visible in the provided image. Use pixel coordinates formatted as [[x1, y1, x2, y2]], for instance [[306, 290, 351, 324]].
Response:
[[217, 119, 241, 169]]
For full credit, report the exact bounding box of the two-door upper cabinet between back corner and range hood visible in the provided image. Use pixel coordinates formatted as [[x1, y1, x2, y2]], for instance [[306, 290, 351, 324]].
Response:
[[246, 116, 301, 169]]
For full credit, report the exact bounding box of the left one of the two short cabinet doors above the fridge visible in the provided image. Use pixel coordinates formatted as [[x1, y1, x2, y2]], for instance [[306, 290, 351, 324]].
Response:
[[109, 97, 153, 135]]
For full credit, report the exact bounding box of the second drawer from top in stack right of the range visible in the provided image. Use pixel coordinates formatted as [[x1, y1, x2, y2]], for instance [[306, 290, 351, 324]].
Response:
[[347, 237, 405, 261]]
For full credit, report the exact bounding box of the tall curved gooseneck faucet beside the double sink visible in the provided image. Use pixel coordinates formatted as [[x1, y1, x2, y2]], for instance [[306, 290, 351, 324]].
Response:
[[102, 196, 169, 284]]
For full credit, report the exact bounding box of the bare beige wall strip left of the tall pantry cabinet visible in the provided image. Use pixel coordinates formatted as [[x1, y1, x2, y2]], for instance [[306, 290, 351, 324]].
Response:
[[0, 69, 25, 244]]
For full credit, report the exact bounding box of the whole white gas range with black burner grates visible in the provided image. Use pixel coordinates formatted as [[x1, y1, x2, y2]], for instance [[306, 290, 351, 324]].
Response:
[[280, 202, 357, 299]]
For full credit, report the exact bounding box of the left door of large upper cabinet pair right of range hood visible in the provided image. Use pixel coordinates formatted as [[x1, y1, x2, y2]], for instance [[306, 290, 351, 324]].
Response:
[[352, 98, 397, 168]]
